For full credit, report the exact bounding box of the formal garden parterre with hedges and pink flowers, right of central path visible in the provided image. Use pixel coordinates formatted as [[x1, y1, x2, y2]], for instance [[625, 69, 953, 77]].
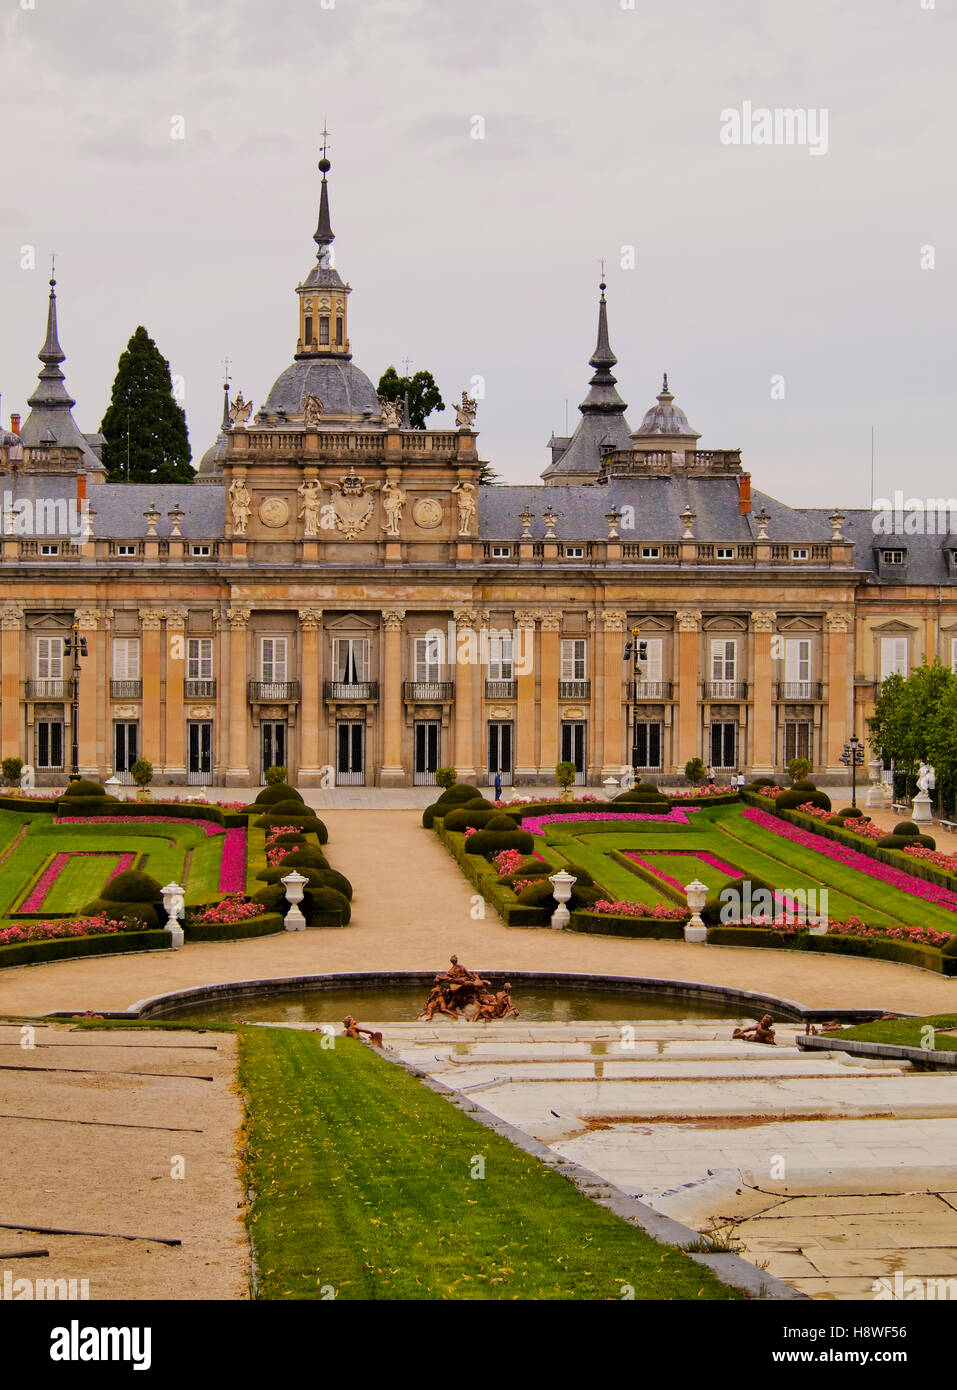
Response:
[[423, 778, 957, 974]]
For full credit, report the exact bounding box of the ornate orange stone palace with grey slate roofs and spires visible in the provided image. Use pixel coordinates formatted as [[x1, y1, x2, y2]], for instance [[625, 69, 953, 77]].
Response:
[[0, 158, 957, 787]]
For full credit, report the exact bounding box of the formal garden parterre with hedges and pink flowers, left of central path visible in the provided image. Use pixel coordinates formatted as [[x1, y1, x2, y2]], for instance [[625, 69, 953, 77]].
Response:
[[0, 769, 352, 967]]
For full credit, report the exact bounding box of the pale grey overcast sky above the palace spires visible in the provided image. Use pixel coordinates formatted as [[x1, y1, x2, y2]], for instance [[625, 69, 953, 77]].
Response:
[[0, 0, 957, 506]]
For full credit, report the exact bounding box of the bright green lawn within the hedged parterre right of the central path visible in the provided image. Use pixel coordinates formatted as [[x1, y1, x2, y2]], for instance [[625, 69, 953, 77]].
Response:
[[537, 806, 957, 931]]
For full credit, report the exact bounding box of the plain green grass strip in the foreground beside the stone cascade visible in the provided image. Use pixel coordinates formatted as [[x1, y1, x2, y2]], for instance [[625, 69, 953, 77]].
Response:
[[239, 1027, 736, 1301]]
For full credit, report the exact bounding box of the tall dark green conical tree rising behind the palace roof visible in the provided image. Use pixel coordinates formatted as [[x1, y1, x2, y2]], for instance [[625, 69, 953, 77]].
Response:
[[100, 325, 196, 482]]
